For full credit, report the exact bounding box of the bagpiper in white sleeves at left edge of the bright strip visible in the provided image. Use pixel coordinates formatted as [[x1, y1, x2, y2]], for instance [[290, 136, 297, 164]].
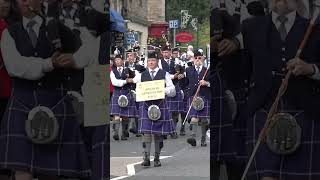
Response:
[[110, 55, 137, 140]]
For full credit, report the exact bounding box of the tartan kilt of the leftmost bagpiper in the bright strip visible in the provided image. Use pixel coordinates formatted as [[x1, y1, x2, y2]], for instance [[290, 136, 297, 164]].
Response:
[[110, 90, 138, 117]]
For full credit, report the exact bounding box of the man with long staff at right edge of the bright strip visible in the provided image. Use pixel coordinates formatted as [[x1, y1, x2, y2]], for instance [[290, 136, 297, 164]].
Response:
[[186, 50, 211, 146]]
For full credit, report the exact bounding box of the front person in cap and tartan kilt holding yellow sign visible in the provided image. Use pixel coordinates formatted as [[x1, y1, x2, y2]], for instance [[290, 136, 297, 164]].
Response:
[[128, 52, 176, 167]]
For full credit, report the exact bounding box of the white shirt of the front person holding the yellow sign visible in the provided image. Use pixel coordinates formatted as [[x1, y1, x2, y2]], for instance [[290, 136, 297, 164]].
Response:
[[133, 67, 176, 97]]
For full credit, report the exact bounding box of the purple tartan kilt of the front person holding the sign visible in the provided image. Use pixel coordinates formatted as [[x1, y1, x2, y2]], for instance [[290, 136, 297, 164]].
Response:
[[138, 100, 175, 135]]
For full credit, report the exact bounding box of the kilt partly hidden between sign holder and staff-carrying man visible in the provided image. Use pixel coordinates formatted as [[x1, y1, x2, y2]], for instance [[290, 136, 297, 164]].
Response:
[[167, 85, 186, 112]]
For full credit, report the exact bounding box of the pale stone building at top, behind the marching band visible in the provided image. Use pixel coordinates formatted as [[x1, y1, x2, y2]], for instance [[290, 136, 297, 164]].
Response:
[[110, 0, 168, 50]]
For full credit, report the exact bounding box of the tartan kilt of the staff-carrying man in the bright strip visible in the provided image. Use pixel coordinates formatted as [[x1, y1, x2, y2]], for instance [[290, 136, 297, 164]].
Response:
[[187, 96, 210, 119]]
